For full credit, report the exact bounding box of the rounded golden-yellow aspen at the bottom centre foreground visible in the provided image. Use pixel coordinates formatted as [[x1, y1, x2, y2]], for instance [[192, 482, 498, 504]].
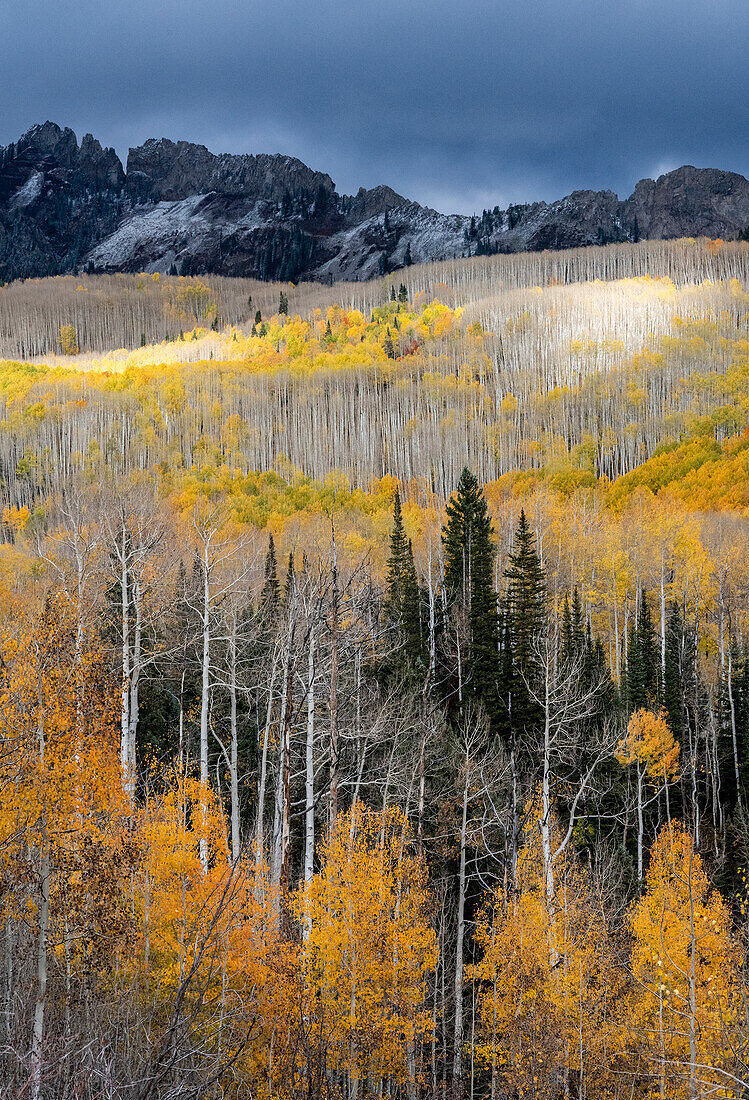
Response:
[[295, 803, 437, 1084]]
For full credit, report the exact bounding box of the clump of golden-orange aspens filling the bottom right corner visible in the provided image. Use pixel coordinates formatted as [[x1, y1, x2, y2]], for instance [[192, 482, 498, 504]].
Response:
[[474, 822, 744, 1100]]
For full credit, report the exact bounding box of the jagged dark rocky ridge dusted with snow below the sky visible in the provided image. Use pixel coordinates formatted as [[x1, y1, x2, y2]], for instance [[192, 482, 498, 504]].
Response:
[[0, 122, 749, 282]]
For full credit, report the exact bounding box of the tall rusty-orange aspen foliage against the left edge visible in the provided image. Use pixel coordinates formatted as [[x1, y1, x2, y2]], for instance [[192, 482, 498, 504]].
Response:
[[0, 596, 132, 980]]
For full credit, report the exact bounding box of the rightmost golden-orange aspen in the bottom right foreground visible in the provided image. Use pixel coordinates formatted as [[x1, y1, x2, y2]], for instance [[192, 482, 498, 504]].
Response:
[[628, 822, 741, 1100]]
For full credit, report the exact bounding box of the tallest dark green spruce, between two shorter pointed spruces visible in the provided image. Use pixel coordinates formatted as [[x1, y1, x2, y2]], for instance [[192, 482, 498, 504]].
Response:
[[442, 468, 499, 728]]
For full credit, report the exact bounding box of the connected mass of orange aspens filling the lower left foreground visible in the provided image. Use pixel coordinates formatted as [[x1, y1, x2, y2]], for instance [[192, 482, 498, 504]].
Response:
[[0, 597, 437, 1096]]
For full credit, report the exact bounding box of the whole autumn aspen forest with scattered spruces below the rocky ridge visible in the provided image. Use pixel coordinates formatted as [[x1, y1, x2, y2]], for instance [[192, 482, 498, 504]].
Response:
[[5, 239, 749, 1100]]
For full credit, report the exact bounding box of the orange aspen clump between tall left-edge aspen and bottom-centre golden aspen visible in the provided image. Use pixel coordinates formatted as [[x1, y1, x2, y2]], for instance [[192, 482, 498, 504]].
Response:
[[127, 773, 281, 1078]]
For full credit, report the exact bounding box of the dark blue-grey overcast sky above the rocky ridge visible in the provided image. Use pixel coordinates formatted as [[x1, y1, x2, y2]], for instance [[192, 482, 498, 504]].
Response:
[[0, 0, 749, 213]]
